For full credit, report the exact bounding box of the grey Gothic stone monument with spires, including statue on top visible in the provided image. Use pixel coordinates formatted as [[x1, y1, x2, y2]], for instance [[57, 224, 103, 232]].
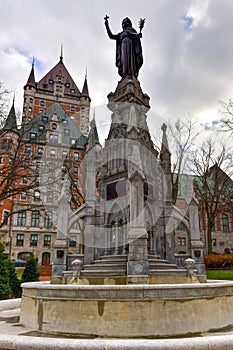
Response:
[[53, 16, 205, 284]]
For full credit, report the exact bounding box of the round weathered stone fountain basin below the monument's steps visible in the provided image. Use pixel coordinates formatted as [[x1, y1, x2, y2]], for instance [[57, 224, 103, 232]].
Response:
[[20, 281, 233, 338]]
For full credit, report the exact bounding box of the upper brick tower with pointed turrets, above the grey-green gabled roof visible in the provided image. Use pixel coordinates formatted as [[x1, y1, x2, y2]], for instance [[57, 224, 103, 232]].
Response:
[[22, 52, 91, 136]]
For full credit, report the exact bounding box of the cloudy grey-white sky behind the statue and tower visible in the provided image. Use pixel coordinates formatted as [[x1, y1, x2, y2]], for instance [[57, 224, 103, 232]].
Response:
[[0, 0, 233, 139]]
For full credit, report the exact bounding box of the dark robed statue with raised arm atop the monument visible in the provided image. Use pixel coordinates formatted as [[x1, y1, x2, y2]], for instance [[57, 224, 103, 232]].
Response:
[[104, 15, 145, 79]]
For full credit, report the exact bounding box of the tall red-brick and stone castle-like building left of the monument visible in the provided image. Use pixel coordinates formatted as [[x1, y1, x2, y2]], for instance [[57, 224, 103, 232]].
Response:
[[0, 53, 91, 264]]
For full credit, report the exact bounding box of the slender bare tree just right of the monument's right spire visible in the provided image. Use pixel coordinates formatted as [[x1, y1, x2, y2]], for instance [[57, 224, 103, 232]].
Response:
[[168, 117, 199, 204]]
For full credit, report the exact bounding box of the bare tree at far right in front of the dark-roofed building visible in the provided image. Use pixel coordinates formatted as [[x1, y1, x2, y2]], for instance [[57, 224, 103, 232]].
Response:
[[192, 138, 233, 254]]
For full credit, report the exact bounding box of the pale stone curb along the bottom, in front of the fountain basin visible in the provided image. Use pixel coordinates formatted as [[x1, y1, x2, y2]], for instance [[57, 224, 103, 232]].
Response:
[[0, 334, 233, 350]]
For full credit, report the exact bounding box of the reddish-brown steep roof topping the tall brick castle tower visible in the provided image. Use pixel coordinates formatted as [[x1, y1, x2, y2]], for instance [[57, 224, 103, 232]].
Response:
[[36, 56, 80, 97]]
